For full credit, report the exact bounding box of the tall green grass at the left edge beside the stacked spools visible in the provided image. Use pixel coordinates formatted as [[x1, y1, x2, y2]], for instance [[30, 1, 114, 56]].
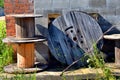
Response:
[[0, 20, 13, 72]]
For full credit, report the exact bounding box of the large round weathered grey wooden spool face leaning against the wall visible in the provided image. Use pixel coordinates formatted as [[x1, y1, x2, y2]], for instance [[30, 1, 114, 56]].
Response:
[[48, 11, 103, 65]]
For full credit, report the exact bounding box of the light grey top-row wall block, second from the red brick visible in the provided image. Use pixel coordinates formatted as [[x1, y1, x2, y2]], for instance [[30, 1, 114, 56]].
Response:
[[52, 0, 70, 9]]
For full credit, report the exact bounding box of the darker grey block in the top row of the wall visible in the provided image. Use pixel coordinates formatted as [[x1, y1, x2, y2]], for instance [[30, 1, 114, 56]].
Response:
[[89, 0, 106, 8]]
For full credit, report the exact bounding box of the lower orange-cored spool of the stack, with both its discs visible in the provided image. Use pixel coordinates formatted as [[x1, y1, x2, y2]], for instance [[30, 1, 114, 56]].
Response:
[[3, 37, 47, 73]]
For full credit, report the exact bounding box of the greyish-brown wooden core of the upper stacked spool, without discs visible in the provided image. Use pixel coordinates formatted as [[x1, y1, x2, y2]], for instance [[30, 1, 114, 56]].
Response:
[[16, 17, 35, 38]]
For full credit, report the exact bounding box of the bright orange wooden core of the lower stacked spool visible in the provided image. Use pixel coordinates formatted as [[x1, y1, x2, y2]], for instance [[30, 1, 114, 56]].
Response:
[[17, 43, 35, 68]]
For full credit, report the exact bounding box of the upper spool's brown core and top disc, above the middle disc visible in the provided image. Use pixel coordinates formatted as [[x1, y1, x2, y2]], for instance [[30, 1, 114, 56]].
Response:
[[7, 14, 42, 38]]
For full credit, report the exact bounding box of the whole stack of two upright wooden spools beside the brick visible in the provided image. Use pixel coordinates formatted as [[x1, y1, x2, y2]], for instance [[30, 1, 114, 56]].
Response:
[[3, 14, 47, 73]]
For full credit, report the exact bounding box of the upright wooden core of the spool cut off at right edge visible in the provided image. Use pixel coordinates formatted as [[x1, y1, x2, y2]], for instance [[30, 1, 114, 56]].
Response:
[[115, 40, 120, 66]]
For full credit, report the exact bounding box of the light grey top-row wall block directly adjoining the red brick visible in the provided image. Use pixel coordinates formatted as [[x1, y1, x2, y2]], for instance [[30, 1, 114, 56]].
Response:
[[34, 0, 52, 10]]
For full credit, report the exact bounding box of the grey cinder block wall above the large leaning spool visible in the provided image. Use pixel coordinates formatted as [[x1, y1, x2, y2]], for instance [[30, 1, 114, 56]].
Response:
[[34, 0, 120, 27]]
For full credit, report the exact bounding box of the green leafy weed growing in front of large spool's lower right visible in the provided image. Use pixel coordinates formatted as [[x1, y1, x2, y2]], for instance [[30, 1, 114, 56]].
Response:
[[87, 44, 116, 80]]
